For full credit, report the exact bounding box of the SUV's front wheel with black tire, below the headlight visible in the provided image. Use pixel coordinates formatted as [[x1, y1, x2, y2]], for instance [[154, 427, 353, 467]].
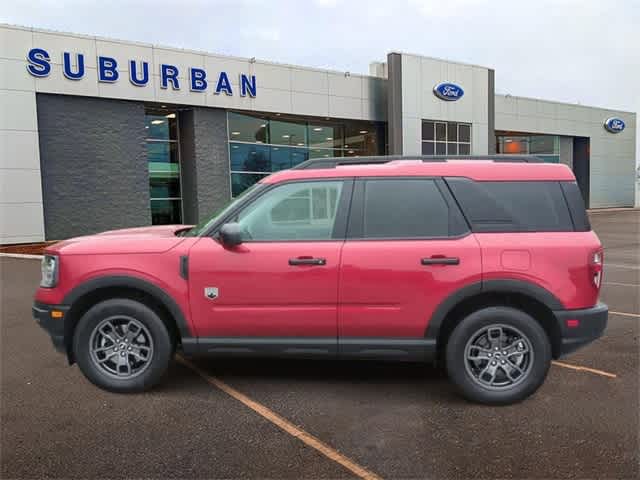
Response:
[[73, 298, 174, 393]]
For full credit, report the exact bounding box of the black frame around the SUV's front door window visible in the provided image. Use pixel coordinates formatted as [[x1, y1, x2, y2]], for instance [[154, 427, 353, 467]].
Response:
[[202, 177, 355, 243]]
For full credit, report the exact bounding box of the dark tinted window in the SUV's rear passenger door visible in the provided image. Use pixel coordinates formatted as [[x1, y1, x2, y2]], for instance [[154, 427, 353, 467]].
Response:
[[349, 178, 468, 239]]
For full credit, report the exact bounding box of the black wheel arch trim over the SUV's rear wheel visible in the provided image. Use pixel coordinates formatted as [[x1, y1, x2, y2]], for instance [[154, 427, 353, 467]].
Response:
[[425, 279, 564, 340]]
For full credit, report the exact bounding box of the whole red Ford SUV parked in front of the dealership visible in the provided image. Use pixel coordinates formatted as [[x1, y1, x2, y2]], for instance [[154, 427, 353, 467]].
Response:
[[33, 156, 608, 404]]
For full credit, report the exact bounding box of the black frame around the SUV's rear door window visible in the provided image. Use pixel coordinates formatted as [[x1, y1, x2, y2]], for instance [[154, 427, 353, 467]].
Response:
[[346, 176, 471, 242]]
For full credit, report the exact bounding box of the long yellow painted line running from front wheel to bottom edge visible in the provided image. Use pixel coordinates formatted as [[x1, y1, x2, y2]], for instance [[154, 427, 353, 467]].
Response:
[[176, 355, 381, 480]]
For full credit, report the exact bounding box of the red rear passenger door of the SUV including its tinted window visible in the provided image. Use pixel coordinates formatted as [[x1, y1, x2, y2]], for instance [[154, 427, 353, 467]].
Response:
[[338, 177, 481, 356]]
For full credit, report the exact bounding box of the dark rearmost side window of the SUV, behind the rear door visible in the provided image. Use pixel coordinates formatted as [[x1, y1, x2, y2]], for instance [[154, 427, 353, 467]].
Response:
[[447, 178, 574, 232]]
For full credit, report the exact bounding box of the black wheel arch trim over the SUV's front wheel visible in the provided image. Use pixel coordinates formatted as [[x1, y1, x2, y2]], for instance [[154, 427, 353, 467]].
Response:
[[63, 275, 192, 339]]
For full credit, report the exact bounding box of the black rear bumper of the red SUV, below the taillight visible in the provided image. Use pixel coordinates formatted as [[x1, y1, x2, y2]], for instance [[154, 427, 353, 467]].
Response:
[[553, 303, 609, 356]]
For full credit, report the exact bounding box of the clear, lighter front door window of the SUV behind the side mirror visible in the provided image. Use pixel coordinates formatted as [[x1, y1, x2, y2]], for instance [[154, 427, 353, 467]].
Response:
[[237, 180, 343, 241]]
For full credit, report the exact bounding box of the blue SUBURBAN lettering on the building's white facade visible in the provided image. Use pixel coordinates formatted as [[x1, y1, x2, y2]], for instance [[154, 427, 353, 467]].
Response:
[[27, 48, 256, 97]]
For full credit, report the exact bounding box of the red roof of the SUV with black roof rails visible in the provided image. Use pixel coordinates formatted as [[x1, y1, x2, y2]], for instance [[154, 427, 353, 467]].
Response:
[[261, 157, 575, 184]]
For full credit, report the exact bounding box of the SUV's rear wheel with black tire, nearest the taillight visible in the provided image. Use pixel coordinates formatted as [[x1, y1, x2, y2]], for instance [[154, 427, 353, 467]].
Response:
[[446, 307, 551, 405]]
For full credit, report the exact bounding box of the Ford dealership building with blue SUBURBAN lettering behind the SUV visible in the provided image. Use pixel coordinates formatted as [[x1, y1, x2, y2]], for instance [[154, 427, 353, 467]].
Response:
[[0, 25, 636, 244]]
